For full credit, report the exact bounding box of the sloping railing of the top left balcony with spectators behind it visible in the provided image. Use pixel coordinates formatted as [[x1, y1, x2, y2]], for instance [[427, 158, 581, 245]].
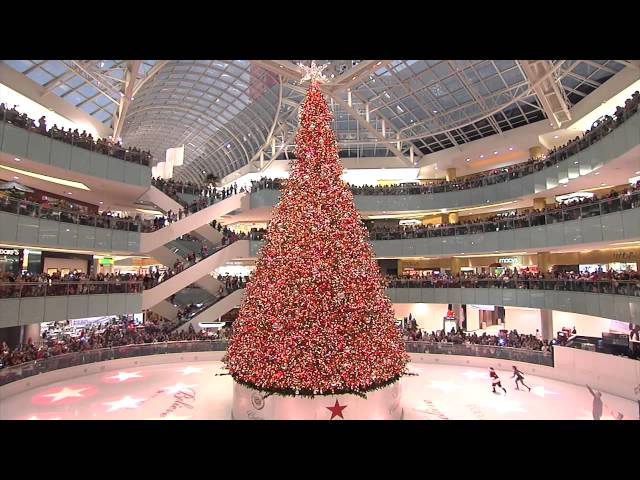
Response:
[[0, 108, 153, 167]]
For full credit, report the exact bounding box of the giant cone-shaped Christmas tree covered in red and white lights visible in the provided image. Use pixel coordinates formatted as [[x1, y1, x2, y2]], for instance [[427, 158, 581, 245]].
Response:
[[225, 62, 408, 395]]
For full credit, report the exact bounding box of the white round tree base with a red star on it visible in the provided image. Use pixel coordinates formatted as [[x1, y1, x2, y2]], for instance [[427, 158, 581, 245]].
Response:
[[231, 380, 403, 420]]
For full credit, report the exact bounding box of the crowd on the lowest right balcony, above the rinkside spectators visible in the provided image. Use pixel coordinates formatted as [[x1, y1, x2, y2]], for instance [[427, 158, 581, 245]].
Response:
[[387, 268, 640, 297]]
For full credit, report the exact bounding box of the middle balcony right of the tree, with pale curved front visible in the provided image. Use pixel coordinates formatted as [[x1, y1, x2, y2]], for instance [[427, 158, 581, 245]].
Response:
[[250, 190, 640, 258]]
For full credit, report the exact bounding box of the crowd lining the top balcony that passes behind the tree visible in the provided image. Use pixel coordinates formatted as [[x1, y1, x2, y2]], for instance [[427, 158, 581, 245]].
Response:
[[246, 91, 640, 195]]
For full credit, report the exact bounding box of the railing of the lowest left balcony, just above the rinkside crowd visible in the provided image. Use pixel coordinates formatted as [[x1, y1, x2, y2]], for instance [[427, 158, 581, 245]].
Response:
[[0, 281, 143, 298]]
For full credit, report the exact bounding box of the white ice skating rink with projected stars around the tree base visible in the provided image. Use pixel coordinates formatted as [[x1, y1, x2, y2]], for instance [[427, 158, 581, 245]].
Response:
[[0, 361, 638, 420]]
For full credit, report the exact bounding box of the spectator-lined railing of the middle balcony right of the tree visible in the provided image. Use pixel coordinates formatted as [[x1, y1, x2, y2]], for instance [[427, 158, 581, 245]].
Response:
[[369, 190, 640, 240]]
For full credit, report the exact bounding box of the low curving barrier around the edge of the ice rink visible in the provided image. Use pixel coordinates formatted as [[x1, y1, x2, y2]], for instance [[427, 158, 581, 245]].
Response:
[[0, 340, 553, 385]]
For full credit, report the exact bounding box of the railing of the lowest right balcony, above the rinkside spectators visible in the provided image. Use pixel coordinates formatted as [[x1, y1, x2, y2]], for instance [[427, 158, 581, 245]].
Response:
[[388, 277, 640, 297]]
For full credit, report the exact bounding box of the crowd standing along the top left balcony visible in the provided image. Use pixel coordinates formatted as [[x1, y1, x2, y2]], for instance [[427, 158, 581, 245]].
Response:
[[0, 103, 153, 166]]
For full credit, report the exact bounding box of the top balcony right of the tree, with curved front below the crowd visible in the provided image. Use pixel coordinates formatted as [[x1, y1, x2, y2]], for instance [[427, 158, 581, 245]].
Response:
[[250, 106, 640, 213]]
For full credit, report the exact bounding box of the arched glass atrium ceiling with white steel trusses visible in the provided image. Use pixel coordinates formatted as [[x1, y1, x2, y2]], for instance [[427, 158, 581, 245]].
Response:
[[4, 60, 627, 181]]
